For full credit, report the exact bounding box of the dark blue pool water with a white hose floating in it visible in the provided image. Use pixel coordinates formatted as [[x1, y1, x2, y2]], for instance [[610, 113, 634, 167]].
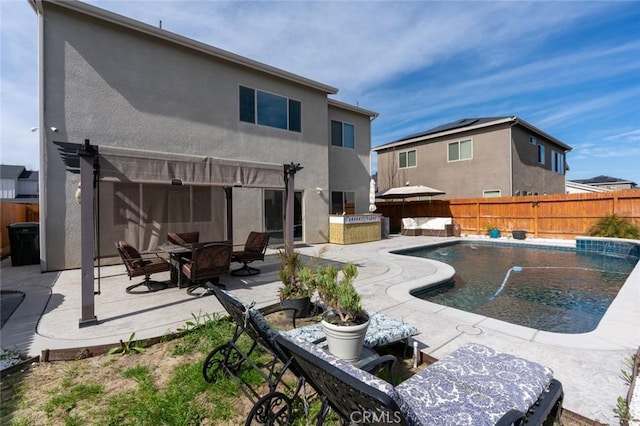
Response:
[[399, 242, 638, 333]]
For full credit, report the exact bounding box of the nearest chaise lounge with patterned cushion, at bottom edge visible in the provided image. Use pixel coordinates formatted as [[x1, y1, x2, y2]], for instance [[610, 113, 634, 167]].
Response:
[[276, 336, 563, 426]]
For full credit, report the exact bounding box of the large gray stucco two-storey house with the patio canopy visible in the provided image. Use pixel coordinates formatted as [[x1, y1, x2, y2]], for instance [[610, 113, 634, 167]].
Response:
[[30, 0, 377, 270]]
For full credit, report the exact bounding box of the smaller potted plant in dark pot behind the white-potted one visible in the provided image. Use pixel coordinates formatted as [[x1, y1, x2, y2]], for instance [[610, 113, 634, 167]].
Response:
[[278, 245, 314, 318]]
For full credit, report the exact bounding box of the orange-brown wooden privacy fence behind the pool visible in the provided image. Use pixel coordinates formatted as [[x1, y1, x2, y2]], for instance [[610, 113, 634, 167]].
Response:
[[376, 189, 640, 238]]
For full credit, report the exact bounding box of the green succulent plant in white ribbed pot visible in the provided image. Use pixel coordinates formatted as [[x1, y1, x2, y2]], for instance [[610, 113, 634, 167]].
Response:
[[314, 263, 369, 361]]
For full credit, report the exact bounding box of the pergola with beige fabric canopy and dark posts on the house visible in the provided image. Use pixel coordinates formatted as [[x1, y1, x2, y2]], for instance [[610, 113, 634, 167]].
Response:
[[54, 139, 302, 327]]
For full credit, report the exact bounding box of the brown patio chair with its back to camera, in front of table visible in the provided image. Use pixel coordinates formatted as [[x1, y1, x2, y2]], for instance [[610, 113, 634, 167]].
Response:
[[180, 242, 232, 296]]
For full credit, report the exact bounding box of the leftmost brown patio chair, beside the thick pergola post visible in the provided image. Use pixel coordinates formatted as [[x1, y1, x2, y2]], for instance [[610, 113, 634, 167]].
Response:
[[116, 241, 170, 293]]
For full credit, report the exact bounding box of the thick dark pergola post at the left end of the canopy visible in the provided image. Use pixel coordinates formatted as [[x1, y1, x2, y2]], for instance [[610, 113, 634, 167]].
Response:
[[78, 139, 98, 327]]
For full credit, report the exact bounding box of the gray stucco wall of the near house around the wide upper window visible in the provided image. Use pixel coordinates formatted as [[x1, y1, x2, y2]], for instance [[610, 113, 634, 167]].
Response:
[[42, 3, 336, 270]]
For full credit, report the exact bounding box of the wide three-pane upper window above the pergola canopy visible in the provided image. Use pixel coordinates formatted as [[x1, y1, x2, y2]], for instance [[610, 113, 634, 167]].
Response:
[[239, 86, 302, 132]]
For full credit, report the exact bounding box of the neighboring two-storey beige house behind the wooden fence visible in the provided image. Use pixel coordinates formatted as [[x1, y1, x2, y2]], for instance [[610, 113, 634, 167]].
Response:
[[372, 116, 571, 199]]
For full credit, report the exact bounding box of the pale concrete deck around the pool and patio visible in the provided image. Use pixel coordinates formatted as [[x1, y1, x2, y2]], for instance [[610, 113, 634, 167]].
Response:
[[0, 235, 640, 424]]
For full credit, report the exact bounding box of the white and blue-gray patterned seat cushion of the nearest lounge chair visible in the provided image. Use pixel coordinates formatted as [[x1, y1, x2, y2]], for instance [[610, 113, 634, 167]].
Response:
[[396, 343, 553, 425]]
